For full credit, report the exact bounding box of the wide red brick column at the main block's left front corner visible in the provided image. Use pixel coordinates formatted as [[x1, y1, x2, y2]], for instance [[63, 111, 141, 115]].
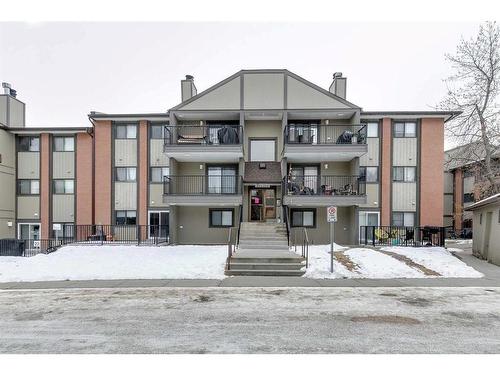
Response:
[[94, 121, 113, 225]]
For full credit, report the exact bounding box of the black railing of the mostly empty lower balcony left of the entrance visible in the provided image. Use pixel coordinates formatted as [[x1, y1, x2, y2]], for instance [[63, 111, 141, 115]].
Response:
[[163, 175, 243, 195]]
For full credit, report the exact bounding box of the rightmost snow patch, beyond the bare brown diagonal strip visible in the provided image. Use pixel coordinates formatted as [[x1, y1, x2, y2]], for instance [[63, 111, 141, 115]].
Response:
[[384, 247, 484, 277]]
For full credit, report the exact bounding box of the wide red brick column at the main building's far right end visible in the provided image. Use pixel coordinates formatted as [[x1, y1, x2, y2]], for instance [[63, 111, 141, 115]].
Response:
[[419, 118, 444, 226]]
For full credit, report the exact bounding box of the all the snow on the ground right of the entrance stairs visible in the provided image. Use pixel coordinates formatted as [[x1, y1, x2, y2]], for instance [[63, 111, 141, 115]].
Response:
[[305, 245, 483, 279]]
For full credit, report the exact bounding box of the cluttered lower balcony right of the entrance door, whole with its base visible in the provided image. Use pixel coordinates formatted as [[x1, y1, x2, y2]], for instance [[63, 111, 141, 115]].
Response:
[[283, 176, 366, 207]]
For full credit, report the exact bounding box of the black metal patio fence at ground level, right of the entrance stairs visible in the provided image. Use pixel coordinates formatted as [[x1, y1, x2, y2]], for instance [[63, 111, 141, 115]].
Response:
[[359, 226, 446, 247]]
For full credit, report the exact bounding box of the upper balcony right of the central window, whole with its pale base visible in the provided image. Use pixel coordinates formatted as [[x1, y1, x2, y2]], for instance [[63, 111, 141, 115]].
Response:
[[283, 124, 368, 162]]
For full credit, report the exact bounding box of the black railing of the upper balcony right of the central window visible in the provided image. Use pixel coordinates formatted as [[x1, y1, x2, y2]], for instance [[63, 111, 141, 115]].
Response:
[[284, 124, 366, 145]]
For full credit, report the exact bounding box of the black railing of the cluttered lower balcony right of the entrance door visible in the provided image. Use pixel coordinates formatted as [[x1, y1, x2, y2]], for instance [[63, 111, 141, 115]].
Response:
[[283, 175, 366, 196]]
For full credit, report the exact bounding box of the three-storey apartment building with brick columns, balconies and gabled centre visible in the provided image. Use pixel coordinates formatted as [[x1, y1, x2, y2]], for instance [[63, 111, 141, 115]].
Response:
[[0, 69, 454, 244]]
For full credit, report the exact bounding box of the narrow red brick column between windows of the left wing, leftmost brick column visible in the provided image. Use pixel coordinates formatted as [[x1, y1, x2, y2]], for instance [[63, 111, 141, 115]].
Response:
[[40, 133, 52, 239]]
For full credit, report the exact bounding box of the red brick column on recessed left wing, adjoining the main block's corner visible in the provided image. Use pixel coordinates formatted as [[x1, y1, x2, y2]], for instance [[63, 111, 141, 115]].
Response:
[[75, 133, 94, 225]]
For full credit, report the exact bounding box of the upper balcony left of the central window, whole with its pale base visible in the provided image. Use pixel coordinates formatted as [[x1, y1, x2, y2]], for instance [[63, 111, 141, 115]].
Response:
[[163, 124, 243, 162]]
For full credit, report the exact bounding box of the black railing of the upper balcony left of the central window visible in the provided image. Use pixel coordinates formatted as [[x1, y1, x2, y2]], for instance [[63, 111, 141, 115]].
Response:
[[163, 124, 243, 146]]
